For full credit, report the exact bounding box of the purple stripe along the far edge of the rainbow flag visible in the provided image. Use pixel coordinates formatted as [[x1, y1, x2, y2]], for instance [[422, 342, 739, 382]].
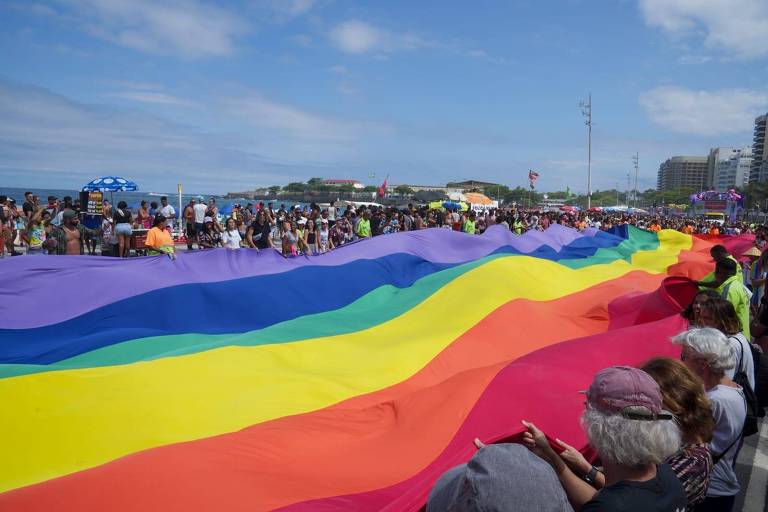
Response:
[[0, 225, 596, 329]]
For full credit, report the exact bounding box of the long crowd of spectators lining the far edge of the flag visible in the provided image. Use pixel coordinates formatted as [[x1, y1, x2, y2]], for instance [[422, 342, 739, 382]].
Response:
[[0, 192, 768, 257]]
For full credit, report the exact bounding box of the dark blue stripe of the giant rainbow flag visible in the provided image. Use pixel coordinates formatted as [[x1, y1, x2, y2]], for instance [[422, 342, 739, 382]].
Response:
[[0, 233, 623, 364]]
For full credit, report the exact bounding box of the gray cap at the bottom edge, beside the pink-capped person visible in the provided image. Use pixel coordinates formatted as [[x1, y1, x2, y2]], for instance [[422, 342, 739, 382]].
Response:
[[427, 444, 573, 512]]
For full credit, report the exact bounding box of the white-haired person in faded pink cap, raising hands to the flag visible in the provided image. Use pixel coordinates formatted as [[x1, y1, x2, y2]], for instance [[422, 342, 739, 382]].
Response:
[[523, 366, 688, 512]]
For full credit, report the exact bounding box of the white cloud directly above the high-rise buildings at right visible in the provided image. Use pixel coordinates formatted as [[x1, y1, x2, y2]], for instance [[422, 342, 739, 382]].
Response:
[[640, 87, 768, 136]]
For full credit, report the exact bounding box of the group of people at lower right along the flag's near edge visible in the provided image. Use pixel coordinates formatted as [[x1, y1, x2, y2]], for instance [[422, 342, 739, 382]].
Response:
[[427, 245, 768, 512]]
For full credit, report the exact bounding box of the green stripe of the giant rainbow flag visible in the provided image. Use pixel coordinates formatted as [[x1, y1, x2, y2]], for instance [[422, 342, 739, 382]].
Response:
[[0, 229, 659, 378]]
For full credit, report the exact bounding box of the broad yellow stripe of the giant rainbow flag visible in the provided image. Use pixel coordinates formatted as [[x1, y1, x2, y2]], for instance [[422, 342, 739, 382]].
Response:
[[0, 232, 691, 491]]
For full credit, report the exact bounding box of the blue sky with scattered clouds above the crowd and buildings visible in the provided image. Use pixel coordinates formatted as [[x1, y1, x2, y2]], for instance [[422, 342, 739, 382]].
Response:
[[0, 0, 768, 193]]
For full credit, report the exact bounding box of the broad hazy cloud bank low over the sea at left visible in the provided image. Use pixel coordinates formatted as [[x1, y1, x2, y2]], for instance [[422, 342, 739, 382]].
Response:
[[0, 79, 374, 192]]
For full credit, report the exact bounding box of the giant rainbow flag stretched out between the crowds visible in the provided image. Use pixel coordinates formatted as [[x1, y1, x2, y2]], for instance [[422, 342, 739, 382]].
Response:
[[0, 226, 751, 512]]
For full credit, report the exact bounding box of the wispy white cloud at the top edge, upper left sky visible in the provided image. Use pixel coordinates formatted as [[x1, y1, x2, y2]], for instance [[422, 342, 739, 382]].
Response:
[[51, 0, 247, 58]]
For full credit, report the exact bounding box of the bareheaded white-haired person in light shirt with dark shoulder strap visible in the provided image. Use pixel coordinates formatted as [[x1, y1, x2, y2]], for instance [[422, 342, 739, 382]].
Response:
[[672, 327, 747, 512]]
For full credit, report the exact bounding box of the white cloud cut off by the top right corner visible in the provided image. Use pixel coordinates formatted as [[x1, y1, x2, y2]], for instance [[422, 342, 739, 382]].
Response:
[[640, 0, 768, 59]]
